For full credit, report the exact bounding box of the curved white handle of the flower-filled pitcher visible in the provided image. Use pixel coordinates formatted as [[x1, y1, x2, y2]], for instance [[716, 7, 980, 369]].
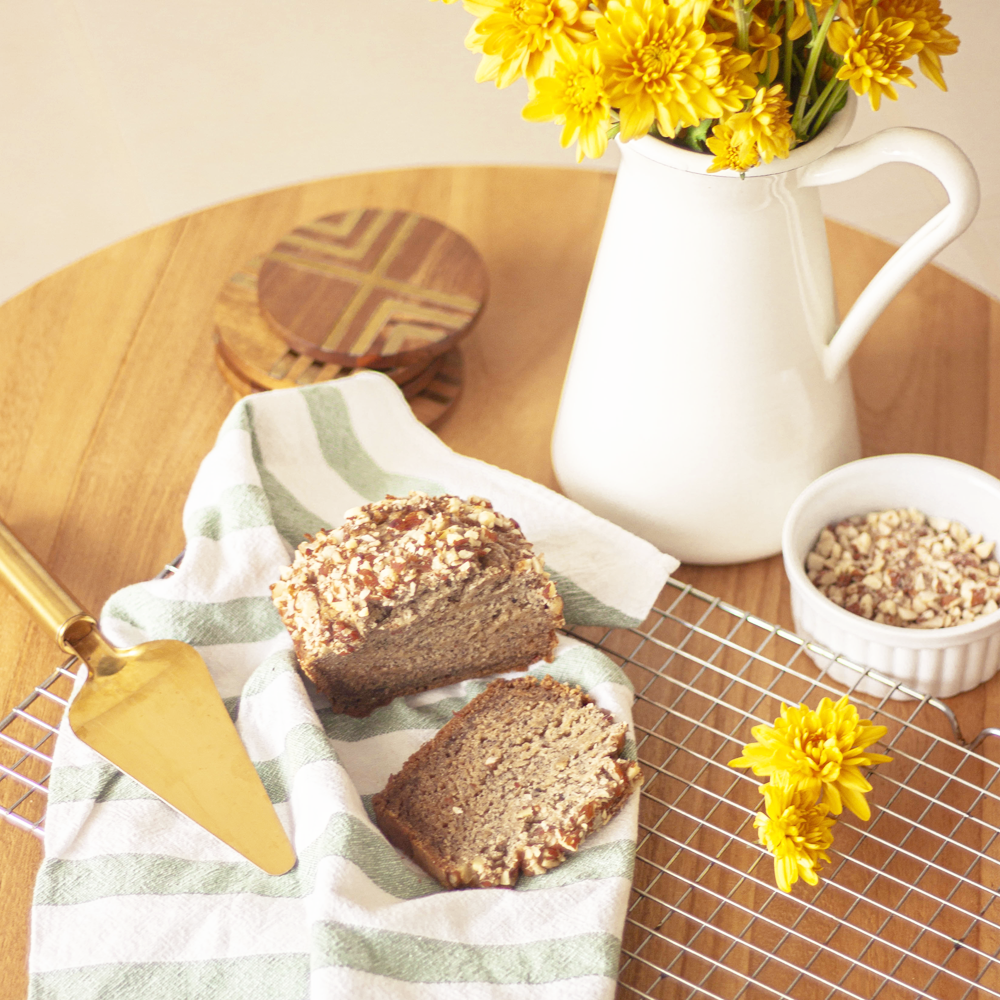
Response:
[[799, 128, 979, 381]]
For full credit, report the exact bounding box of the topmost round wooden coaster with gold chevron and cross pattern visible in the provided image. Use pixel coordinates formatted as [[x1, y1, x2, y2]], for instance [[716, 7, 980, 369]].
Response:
[[258, 208, 488, 369]]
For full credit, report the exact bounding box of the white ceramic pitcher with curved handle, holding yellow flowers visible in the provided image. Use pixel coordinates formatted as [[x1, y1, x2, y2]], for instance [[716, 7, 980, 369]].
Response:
[[552, 95, 979, 563]]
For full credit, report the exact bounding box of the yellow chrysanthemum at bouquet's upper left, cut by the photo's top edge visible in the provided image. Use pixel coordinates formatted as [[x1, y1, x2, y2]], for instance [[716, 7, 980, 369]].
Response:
[[464, 0, 597, 87]]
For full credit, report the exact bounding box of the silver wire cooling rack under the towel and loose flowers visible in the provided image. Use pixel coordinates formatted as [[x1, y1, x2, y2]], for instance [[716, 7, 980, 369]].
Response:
[[0, 581, 1000, 1000]]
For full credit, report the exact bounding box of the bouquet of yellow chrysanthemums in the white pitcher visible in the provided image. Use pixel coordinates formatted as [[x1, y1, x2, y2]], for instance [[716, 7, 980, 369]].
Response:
[[432, 0, 959, 173]]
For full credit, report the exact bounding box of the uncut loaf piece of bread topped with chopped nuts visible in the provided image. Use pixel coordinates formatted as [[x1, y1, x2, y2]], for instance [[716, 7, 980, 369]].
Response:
[[271, 492, 563, 716]]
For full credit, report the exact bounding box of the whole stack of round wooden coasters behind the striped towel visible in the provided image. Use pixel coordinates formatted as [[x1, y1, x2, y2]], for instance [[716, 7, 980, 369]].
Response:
[[214, 208, 488, 426]]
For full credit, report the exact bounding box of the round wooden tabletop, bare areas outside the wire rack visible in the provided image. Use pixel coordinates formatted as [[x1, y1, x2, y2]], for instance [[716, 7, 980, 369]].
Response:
[[0, 167, 1000, 998]]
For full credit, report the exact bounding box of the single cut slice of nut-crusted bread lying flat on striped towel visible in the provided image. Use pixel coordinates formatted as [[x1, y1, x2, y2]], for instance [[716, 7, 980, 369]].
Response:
[[372, 677, 642, 888]]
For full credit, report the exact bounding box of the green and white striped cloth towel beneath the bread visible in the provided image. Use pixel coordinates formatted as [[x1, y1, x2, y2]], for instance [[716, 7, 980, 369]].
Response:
[[30, 373, 676, 1000]]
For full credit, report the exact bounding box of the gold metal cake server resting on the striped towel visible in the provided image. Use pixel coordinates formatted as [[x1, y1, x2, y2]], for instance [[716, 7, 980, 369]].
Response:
[[0, 521, 295, 875]]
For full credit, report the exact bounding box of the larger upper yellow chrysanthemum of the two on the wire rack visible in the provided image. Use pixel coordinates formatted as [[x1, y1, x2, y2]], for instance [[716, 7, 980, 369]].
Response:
[[729, 695, 892, 820]]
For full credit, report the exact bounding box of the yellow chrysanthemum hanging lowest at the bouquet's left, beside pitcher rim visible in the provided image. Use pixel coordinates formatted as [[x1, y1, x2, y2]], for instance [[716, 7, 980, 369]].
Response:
[[521, 39, 611, 162]]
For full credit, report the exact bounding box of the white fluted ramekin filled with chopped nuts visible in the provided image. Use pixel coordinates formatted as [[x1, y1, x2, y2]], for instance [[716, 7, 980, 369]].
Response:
[[782, 455, 1000, 698]]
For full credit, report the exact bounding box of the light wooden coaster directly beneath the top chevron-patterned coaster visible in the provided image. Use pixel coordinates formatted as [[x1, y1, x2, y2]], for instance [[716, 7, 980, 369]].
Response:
[[213, 256, 432, 389]]
